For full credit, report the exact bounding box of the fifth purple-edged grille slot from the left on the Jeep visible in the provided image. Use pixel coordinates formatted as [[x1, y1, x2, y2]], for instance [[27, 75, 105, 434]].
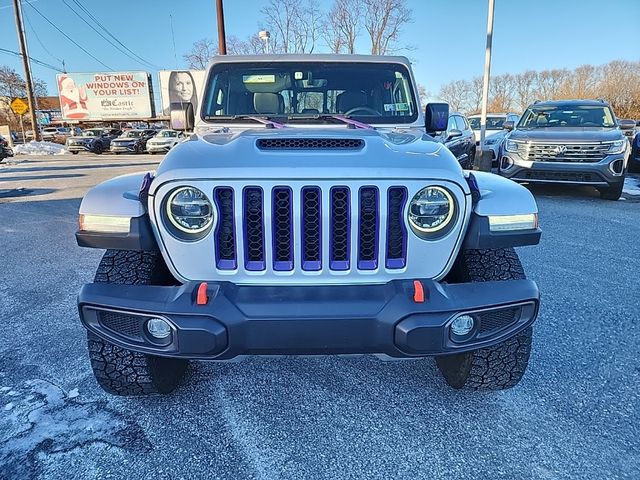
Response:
[[329, 187, 351, 270]]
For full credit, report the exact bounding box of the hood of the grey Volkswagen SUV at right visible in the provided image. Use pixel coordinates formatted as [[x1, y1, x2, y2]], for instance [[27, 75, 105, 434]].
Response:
[[509, 127, 624, 143]]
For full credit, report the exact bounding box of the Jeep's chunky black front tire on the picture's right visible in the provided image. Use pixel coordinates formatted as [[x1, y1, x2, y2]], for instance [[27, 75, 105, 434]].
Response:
[[436, 248, 533, 390]]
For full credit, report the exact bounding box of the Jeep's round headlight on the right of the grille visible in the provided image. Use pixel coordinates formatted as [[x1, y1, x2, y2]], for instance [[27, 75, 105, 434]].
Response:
[[409, 186, 455, 234]]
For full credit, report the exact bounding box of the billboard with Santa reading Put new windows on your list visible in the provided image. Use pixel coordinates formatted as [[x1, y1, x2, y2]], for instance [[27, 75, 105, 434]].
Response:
[[57, 72, 155, 121]]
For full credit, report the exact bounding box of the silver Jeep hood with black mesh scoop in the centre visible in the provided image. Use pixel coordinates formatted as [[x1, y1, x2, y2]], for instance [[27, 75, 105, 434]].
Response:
[[150, 127, 468, 193]]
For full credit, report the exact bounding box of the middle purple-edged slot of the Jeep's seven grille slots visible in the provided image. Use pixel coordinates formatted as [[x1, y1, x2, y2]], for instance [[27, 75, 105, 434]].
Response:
[[301, 187, 322, 271]]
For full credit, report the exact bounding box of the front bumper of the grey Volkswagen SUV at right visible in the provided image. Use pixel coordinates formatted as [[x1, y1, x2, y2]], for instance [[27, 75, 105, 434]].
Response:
[[499, 152, 625, 187]]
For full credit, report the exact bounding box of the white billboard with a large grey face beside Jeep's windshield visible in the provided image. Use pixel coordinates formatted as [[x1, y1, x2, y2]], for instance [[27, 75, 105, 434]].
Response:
[[158, 70, 206, 116]]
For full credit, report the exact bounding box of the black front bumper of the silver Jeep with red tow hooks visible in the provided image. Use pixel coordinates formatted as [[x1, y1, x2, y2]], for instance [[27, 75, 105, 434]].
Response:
[[78, 280, 539, 360]]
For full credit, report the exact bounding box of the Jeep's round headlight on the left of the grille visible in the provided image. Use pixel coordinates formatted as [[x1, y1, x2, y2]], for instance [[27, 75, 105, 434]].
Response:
[[167, 187, 213, 233]]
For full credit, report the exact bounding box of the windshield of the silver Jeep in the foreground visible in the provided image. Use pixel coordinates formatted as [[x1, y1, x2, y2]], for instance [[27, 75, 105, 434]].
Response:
[[202, 62, 418, 124]]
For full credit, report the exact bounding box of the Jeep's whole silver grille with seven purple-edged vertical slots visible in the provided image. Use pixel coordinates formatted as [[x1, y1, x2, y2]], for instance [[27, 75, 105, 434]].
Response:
[[213, 185, 407, 272]]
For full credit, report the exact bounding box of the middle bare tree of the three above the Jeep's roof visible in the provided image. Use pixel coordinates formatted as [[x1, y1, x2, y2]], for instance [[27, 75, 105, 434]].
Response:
[[323, 0, 363, 53]]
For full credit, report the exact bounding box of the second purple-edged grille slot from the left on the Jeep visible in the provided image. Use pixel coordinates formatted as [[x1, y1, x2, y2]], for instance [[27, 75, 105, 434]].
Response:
[[243, 187, 265, 271]]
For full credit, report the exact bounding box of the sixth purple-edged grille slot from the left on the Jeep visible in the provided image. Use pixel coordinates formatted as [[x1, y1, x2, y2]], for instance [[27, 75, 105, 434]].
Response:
[[358, 187, 379, 270]]
